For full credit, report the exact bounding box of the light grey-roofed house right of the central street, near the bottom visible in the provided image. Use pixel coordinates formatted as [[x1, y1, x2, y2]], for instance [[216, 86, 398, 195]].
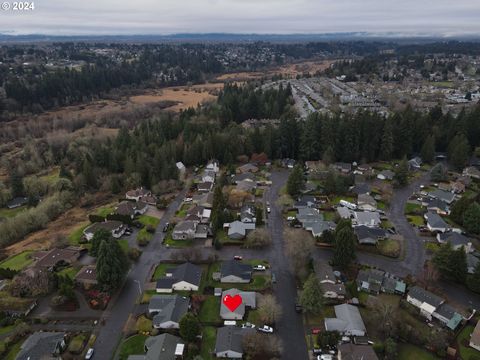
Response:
[[325, 304, 366, 336]]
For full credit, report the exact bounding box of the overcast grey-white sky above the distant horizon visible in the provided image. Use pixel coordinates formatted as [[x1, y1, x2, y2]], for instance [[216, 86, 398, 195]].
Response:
[[0, 0, 480, 36]]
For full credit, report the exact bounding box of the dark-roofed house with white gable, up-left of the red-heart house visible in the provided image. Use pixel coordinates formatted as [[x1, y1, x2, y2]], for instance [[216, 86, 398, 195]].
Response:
[[156, 262, 203, 293]]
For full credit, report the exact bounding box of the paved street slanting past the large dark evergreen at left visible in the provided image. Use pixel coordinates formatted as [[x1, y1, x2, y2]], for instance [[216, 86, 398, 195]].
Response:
[[95, 191, 185, 360]]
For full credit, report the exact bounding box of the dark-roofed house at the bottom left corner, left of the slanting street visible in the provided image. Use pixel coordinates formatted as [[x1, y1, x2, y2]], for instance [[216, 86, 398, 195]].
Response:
[[16, 332, 66, 360]]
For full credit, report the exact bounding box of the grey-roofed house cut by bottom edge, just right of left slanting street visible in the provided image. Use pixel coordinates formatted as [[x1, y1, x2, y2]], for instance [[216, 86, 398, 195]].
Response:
[[127, 333, 185, 360]]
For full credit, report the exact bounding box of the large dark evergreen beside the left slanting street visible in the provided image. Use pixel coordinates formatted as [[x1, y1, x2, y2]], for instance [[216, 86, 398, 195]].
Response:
[[97, 240, 129, 291]]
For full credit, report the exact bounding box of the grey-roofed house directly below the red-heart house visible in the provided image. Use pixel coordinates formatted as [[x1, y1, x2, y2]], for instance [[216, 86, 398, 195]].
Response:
[[215, 326, 255, 359]]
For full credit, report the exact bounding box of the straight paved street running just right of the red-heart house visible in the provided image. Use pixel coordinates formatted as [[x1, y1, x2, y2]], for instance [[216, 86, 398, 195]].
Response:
[[266, 171, 308, 360]]
